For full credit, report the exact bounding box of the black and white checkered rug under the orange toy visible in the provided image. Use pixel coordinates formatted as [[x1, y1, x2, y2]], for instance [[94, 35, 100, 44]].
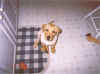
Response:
[[15, 27, 48, 74]]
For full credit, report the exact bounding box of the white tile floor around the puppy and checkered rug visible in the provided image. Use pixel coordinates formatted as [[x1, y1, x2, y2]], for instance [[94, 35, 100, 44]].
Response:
[[19, 0, 100, 74]]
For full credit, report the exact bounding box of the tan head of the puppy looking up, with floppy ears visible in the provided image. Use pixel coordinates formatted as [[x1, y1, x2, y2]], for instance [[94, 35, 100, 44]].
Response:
[[42, 23, 62, 41]]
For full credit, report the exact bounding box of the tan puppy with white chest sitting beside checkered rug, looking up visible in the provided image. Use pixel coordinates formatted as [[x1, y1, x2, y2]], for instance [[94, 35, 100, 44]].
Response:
[[34, 21, 62, 53]]
